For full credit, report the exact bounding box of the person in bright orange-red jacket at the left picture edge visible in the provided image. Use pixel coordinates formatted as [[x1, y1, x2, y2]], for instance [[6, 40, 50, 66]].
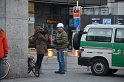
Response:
[[0, 28, 8, 77]]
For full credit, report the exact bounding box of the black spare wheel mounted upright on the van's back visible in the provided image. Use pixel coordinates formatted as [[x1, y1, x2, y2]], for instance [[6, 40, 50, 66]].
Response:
[[73, 32, 82, 50]]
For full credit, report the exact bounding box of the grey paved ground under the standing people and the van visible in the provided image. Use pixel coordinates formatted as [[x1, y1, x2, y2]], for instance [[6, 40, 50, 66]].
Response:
[[1, 49, 124, 82]]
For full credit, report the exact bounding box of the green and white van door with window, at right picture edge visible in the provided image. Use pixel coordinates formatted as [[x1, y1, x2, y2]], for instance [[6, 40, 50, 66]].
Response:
[[112, 28, 124, 67]]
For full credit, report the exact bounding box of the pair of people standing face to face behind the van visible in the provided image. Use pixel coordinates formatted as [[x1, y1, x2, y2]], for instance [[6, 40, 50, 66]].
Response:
[[34, 23, 68, 74]]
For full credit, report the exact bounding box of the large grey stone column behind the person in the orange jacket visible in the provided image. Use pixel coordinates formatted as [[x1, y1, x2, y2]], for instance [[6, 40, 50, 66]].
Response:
[[0, 0, 28, 78]]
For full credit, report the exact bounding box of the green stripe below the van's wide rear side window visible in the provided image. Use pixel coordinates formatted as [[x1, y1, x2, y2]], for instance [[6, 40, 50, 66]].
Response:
[[80, 41, 112, 48]]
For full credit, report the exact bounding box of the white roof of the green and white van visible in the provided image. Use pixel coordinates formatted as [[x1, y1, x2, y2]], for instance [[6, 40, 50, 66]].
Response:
[[84, 24, 124, 31]]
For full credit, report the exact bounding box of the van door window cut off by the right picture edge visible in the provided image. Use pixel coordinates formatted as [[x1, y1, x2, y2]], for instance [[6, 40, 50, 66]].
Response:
[[115, 28, 124, 43]]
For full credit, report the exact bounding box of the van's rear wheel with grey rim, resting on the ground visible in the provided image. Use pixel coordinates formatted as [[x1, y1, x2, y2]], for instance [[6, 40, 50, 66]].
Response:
[[91, 59, 109, 76]]
